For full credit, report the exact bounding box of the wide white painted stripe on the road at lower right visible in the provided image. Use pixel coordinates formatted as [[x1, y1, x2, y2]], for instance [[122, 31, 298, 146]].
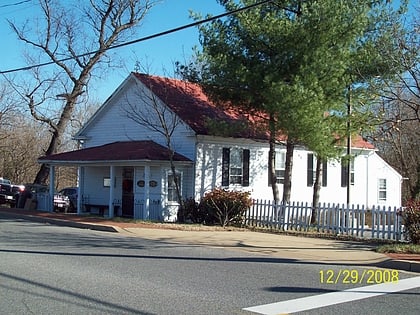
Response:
[[244, 276, 420, 315]]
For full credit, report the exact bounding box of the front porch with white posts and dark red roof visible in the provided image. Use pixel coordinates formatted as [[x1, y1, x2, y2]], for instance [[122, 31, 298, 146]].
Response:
[[39, 141, 193, 221]]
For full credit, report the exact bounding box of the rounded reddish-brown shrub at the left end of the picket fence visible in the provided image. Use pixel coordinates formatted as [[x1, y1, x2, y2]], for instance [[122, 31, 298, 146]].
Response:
[[199, 188, 252, 227]]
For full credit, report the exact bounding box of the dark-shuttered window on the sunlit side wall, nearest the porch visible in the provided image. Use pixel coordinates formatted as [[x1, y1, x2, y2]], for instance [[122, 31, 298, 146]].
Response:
[[222, 148, 249, 186]]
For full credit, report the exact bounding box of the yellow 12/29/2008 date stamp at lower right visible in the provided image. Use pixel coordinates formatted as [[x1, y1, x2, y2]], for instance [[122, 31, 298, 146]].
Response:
[[319, 269, 399, 284]]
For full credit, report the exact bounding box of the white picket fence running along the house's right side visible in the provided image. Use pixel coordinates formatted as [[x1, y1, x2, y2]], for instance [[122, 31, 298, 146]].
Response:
[[245, 200, 404, 241]]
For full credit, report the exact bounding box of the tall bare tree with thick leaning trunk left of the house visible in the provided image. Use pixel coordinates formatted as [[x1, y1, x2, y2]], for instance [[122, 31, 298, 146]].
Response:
[[9, 0, 156, 183]]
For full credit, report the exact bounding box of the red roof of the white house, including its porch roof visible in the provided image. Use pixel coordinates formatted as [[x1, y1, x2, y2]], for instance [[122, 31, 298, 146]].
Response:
[[39, 73, 374, 163]]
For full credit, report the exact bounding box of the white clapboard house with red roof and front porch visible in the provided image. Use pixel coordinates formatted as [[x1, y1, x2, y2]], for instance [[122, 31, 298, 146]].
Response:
[[39, 73, 402, 221]]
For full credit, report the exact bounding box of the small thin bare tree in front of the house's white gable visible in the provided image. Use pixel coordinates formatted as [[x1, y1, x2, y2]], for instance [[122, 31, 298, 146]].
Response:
[[122, 77, 183, 215]]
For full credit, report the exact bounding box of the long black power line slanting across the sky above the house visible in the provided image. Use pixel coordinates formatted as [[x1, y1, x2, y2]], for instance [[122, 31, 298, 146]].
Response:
[[0, 0, 273, 75]]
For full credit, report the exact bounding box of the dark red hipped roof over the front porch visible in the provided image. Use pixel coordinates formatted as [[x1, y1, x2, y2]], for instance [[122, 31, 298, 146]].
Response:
[[38, 140, 192, 164]]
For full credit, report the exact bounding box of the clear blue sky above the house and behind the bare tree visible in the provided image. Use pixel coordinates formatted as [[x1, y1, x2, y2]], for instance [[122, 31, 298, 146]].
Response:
[[0, 0, 224, 102]]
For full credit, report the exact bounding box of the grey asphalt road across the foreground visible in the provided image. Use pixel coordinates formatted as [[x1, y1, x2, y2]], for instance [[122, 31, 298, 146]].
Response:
[[0, 215, 420, 315]]
